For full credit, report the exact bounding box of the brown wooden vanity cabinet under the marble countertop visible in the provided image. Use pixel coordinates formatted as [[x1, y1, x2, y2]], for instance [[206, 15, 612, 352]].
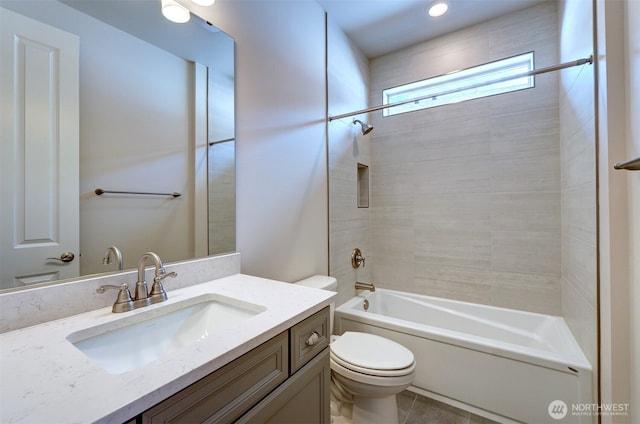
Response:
[[138, 307, 331, 424]]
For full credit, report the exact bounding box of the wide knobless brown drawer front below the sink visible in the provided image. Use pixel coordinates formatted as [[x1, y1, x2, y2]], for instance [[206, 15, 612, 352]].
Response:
[[142, 331, 289, 424]]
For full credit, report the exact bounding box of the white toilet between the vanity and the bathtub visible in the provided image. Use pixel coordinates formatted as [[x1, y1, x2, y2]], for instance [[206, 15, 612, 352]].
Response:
[[296, 275, 416, 424]]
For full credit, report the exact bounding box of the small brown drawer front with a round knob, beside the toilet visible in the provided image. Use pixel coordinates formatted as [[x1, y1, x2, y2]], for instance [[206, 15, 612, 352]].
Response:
[[290, 306, 331, 374]]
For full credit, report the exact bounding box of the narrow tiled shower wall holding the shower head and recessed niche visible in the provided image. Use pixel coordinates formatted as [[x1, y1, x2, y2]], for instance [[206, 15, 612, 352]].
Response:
[[327, 16, 372, 305]]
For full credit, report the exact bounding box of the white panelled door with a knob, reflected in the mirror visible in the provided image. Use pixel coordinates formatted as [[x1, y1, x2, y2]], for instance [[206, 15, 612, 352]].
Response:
[[0, 8, 80, 288]]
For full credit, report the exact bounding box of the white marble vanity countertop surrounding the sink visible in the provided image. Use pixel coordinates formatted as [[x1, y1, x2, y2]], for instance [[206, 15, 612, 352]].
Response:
[[0, 274, 335, 423]]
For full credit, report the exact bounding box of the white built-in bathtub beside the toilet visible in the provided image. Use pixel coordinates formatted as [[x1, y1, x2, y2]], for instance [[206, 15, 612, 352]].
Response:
[[335, 289, 595, 424]]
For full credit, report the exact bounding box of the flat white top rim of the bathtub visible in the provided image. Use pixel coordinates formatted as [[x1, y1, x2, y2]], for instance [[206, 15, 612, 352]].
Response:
[[334, 288, 593, 375]]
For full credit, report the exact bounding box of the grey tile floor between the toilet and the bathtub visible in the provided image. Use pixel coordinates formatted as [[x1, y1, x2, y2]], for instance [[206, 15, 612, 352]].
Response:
[[396, 390, 496, 424]]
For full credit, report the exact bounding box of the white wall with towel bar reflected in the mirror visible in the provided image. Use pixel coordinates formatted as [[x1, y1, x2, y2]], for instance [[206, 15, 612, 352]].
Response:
[[80, 21, 194, 275]]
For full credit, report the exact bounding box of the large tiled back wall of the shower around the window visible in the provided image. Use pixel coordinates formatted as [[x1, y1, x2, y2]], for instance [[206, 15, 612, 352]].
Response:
[[365, 2, 562, 315]]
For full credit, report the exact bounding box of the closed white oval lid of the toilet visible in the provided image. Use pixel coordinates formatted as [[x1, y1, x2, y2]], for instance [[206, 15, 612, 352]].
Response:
[[331, 331, 414, 371]]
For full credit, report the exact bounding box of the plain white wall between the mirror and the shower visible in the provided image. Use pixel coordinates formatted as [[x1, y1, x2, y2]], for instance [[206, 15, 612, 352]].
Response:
[[191, 0, 328, 281]]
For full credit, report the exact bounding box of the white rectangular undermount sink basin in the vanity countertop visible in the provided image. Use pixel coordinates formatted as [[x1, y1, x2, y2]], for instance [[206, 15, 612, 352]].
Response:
[[67, 294, 266, 374]]
